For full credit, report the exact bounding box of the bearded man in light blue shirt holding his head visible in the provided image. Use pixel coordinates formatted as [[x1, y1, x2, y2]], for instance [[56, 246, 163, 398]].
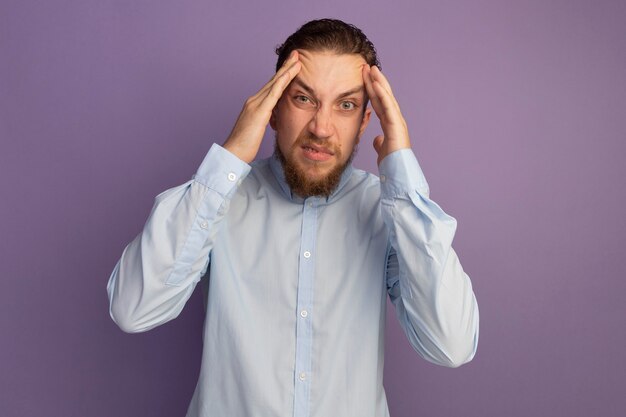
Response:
[[108, 19, 478, 417]]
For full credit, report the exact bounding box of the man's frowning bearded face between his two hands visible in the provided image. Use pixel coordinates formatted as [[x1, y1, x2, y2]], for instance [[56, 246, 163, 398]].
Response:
[[270, 50, 371, 197]]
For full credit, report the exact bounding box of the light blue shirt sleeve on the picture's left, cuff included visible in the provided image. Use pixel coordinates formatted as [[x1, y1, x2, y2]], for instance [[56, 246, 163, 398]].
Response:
[[107, 144, 250, 332]]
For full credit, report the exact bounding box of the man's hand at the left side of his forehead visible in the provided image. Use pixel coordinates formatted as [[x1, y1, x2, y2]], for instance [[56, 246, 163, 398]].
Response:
[[223, 51, 302, 164]]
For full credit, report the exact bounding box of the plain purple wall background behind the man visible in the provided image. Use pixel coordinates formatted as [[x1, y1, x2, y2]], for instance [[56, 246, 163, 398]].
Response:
[[0, 0, 626, 417]]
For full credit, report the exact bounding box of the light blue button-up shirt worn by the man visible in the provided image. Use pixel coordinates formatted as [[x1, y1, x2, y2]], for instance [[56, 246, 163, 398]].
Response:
[[107, 145, 478, 417]]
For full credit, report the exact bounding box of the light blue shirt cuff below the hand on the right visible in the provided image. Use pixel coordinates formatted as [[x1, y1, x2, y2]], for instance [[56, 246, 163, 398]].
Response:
[[378, 149, 429, 198]]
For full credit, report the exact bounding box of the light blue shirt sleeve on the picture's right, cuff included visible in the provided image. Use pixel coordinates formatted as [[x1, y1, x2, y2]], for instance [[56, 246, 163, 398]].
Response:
[[379, 149, 478, 367]]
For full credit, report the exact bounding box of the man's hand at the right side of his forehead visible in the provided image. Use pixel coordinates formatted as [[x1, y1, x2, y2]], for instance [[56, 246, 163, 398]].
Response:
[[363, 65, 411, 165]]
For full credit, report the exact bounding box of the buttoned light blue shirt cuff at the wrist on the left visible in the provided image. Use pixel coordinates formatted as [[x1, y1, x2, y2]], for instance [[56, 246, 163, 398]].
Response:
[[193, 143, 250, 197]]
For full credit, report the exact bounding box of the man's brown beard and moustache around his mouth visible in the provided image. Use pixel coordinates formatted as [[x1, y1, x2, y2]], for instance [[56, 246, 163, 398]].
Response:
[[274, 134, 357, 198]]
